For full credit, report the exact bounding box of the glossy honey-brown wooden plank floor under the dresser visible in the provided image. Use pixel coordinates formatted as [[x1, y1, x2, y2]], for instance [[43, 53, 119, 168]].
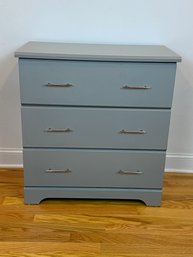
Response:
[[0, 169, 193, 257]]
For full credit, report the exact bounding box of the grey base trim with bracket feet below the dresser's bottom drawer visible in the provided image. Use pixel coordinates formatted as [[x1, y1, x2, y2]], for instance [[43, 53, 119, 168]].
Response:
[[24, 187, 162, 206]]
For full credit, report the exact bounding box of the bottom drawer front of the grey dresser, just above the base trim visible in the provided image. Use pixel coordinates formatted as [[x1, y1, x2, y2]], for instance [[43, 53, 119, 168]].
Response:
[[24, 149, 165, 188]]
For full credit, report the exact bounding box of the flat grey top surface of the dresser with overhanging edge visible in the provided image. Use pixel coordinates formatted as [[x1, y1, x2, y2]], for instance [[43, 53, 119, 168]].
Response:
[[15, 41, 181, 62]]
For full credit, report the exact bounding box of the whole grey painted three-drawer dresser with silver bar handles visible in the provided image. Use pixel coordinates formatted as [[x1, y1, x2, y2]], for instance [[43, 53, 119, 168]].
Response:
[[15, 42, 181, 206]]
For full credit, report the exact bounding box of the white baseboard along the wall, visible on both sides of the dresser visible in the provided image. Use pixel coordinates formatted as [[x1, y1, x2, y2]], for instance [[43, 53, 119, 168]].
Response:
[[0, 148, 193, 173]]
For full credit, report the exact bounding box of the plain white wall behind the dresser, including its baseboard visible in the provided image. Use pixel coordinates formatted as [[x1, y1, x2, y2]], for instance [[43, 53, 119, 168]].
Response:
[[0, 0, 193, 170]]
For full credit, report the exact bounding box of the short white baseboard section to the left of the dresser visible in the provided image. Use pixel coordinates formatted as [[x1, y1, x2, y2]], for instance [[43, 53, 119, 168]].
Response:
[[0, 148, 23, 168]]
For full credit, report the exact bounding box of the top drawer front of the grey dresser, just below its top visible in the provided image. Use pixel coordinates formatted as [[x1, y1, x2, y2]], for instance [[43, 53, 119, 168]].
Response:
[[19, 59, 176, 108]]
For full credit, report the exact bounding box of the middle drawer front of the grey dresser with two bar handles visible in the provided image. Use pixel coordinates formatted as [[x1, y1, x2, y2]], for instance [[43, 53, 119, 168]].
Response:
[[22, 107, 170, 149]]
